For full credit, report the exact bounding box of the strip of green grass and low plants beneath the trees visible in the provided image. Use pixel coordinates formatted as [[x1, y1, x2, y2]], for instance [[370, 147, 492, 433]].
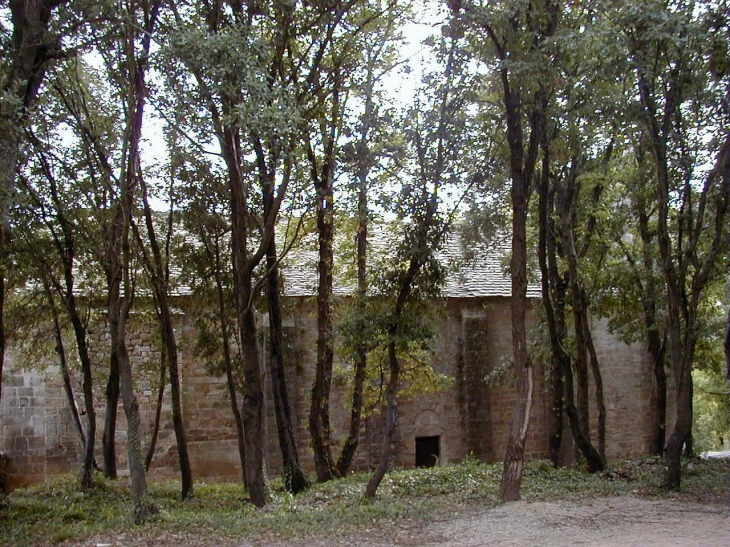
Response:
[[0, 459, 728, 546]]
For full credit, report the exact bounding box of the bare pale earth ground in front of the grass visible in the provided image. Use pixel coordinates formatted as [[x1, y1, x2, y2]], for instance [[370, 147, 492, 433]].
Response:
[[66, 496, 730, 547]]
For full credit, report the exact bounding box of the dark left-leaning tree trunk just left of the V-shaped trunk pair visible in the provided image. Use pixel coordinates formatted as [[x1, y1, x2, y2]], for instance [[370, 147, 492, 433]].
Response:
[[266, 233, 309, 494]]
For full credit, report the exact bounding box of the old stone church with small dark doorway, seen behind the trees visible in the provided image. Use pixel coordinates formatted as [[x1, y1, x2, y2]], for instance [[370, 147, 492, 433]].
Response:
[[0, 240, 652, 489]]
